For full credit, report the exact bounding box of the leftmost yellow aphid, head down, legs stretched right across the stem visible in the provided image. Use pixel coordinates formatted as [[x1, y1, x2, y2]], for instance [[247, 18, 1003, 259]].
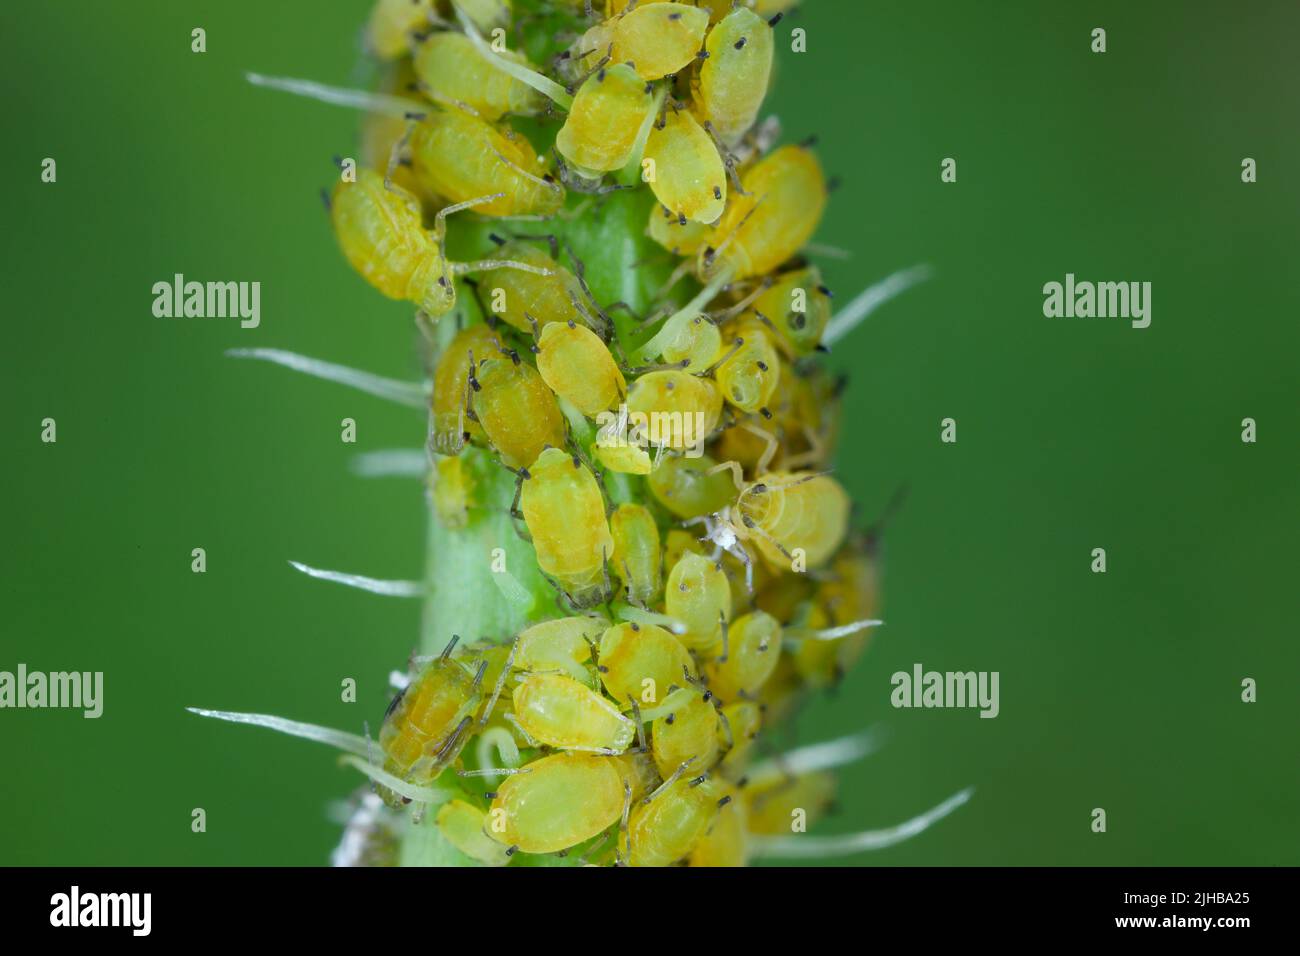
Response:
[[330, 169, 551, 319]]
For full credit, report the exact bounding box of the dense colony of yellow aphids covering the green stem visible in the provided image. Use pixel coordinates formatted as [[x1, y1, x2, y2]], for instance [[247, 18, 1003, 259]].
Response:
[[340, 0, 878, 865]]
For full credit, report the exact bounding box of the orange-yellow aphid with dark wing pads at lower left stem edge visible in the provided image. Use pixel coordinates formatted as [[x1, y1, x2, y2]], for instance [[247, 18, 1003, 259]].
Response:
[[380, 639, 482, 806]]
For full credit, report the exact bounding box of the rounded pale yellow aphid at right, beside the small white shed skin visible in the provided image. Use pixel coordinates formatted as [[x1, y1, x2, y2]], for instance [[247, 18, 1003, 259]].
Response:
[[736, 472, 849, 568]]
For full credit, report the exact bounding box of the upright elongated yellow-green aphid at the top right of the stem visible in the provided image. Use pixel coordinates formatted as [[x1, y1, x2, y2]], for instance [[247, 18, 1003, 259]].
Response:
[[694, 7, 776, 147]]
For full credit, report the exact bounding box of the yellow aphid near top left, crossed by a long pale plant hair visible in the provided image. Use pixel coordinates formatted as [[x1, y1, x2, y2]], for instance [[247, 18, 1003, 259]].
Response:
[[413, 33, 546, 122]]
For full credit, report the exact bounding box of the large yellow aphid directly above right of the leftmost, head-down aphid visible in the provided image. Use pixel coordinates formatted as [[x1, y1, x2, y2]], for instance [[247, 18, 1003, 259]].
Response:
[[408, 109, 564, 216]]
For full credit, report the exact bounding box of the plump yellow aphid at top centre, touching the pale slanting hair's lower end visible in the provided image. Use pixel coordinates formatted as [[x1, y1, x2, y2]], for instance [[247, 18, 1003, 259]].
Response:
[[555, 64, 654, 178]]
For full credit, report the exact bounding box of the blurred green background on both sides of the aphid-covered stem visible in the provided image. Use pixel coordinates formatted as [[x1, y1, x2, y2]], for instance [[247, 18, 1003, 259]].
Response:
[[0, 0, 1300, 865]]
